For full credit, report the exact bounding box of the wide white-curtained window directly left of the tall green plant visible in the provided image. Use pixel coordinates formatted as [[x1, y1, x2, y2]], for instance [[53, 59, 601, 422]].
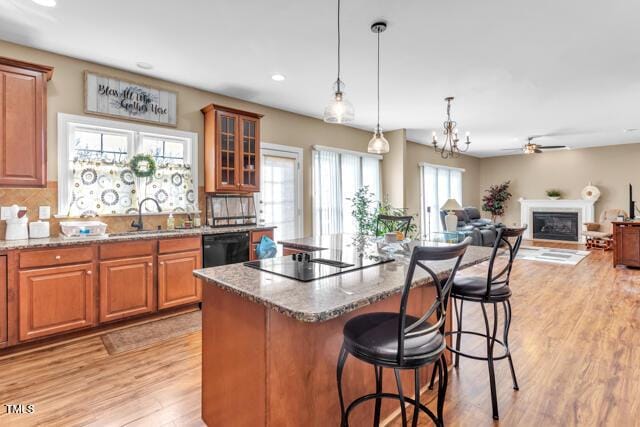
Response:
[[313, 146, 382, 236]]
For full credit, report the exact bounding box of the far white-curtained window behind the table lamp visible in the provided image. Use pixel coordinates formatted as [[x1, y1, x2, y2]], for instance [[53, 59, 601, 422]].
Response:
[[420, 163, 464, 237]]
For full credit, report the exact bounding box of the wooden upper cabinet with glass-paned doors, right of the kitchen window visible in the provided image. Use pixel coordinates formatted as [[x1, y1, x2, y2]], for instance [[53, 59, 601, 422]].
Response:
[[201, 104, 262, 193]]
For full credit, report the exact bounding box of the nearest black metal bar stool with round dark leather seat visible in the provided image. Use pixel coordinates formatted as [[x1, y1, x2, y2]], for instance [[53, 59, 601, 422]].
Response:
[[336, 238, 471, 427]]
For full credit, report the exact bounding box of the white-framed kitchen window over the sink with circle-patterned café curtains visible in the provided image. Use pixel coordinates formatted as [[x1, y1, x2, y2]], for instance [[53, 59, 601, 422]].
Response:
[[58, 114, 198, 217]]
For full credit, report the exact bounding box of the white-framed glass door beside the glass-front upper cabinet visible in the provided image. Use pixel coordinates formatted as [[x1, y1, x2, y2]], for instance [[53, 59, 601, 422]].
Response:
[[256, 144, 303, 241]]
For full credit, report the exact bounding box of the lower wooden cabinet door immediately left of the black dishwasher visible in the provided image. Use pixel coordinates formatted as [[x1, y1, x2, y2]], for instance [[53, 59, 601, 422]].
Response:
[[158, 251, 202, 310]]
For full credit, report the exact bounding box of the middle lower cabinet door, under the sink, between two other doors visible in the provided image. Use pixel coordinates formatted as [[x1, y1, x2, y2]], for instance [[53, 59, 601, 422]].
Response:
[[100, 256, 155, 322]]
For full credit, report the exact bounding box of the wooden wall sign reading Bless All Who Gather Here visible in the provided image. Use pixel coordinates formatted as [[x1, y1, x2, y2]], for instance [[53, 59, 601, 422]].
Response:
[[84, 71, 178, 127]]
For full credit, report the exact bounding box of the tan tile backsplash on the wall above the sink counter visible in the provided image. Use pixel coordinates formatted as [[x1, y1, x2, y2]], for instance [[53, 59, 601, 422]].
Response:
[[0, 181, 204, 239]]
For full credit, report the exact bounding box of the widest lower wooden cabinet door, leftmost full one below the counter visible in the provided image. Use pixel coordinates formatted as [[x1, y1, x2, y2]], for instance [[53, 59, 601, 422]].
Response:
[[18, 264, 95, 341]]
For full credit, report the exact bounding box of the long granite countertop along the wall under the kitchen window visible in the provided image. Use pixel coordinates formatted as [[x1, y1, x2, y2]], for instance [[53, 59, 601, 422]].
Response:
[[0, 225, 274, 252]]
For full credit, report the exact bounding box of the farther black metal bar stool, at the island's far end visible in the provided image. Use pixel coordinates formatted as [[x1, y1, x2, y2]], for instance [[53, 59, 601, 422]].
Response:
[[429, 225, 527, 420]]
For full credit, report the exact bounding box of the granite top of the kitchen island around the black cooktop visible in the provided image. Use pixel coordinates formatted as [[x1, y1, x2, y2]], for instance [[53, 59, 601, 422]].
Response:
[[194, 234, 491, 322]]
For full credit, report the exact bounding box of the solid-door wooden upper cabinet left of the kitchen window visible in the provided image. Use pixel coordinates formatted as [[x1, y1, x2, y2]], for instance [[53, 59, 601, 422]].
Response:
[[0, 57, 53, 187]]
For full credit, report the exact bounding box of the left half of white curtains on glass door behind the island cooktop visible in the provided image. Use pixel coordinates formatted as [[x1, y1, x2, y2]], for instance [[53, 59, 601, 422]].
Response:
[[313, 151, 342, 236]]
